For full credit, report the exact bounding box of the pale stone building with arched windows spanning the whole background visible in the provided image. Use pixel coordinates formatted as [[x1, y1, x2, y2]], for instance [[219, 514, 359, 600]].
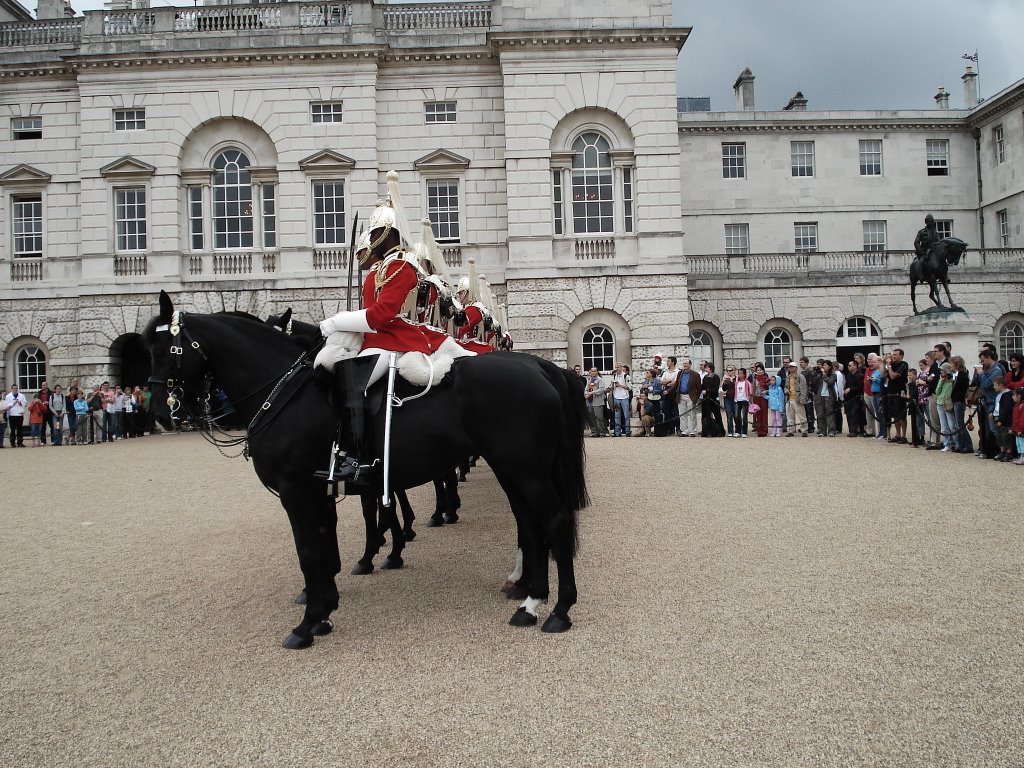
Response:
[[0, 0, 1024, 389]]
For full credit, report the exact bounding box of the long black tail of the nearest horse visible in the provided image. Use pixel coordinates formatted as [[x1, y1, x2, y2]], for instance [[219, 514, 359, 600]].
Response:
[[544, 362, 590, 555]]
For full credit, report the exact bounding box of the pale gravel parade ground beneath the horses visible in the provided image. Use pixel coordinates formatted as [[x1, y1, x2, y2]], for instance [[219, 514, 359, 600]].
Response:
[[0, 435, 1024, 768]]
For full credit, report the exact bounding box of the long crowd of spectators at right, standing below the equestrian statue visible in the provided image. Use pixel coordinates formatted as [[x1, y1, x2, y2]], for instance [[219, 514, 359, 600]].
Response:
[[575, 342, 1024, 464]]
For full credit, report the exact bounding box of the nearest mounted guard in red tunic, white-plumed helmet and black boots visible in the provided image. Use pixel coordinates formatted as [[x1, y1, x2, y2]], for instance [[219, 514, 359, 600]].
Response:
[[315, 199, 447, 483]]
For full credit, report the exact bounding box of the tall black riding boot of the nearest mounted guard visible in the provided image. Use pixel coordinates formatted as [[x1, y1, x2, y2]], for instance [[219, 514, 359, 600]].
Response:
[[313, 355, 377, 496]]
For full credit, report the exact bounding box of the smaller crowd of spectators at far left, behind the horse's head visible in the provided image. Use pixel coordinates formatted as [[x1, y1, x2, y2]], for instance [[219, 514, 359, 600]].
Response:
[[0, 379, 152, 449]]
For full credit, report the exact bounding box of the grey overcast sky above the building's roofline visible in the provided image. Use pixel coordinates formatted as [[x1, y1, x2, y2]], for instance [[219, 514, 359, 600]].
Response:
[[28, 0, 1024, 111]]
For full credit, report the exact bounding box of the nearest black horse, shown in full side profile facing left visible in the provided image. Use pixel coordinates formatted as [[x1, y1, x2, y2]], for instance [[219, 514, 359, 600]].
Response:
[[145, 292, 589, 648]]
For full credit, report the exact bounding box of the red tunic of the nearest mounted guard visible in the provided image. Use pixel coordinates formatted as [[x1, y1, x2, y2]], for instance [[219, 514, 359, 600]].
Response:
[[362, 258, 447, 354]]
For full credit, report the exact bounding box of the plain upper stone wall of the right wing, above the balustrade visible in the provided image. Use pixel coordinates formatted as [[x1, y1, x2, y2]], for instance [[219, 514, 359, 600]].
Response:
[[680, 113, 978, 256]]
